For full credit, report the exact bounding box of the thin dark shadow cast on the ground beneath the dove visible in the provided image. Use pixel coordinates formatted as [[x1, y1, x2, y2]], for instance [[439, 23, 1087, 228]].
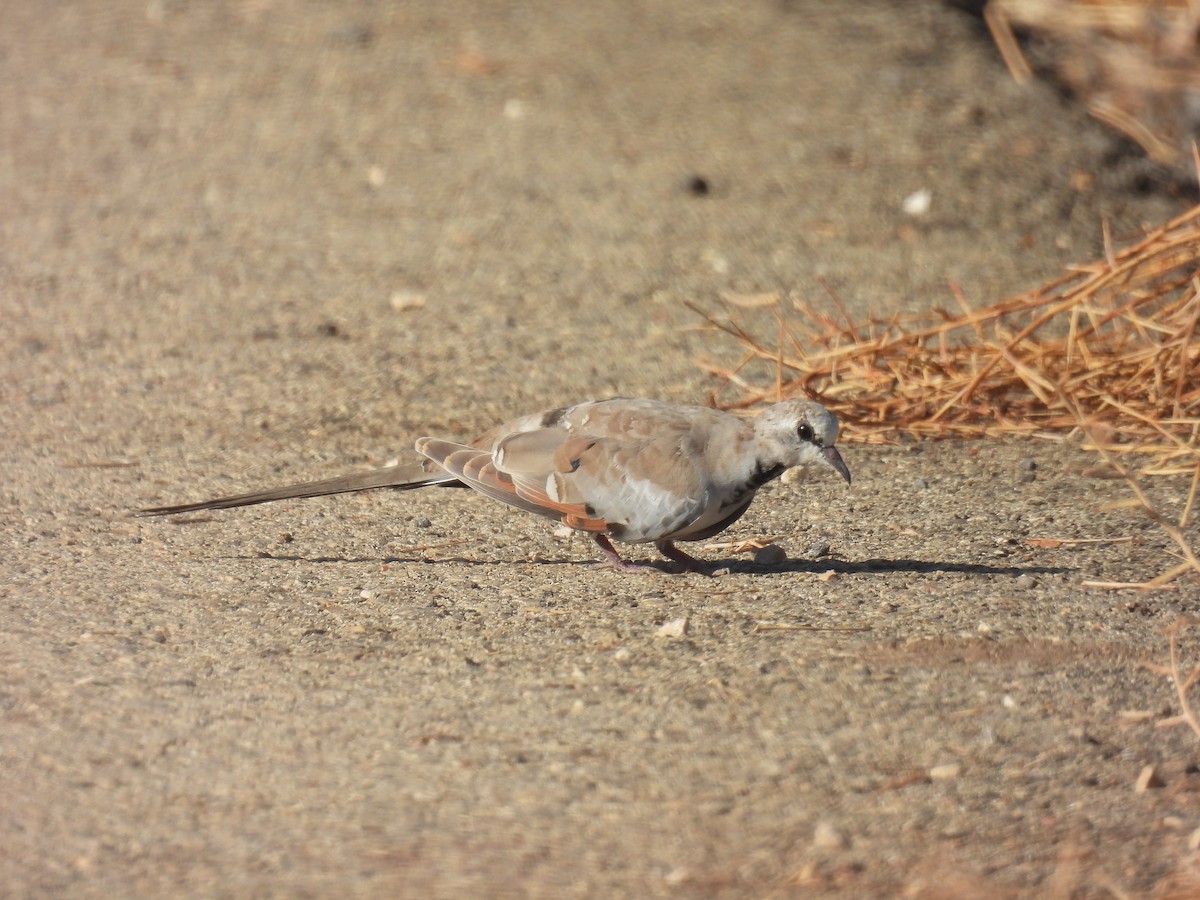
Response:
[[234, 552, 1074, 578]]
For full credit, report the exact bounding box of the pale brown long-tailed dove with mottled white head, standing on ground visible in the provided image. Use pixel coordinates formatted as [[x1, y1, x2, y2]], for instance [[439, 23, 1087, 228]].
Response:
[[136, 397, 850, 572]]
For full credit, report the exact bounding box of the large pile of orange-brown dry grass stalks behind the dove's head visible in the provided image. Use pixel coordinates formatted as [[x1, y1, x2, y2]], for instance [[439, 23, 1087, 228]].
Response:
[[692, 206, 1200, 587]]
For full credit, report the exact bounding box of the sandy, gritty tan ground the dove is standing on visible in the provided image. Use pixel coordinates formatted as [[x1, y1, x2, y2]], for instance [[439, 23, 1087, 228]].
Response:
[[7, 0, 1200, 898]]
